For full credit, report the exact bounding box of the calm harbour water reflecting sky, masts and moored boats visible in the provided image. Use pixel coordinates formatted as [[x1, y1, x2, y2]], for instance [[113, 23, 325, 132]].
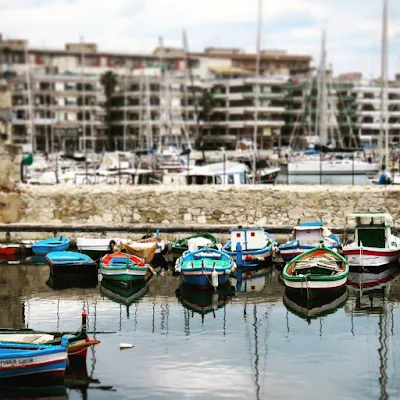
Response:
[[0, 265, 400, 400]]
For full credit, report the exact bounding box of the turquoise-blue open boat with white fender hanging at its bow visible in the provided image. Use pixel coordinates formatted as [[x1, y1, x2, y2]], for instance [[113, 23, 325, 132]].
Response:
[[175, 248, 236, 288]]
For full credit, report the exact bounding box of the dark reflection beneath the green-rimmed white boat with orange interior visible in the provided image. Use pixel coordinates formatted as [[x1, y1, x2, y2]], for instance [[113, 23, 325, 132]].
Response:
[[283, 286, 348, 323]]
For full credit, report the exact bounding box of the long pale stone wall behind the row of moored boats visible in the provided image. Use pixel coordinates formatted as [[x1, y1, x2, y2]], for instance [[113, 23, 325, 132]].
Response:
[[5, 185, 400, 228]]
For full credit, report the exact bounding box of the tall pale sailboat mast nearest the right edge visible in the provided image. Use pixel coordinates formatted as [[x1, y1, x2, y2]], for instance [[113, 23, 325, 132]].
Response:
[[379, 0, 389, 168]]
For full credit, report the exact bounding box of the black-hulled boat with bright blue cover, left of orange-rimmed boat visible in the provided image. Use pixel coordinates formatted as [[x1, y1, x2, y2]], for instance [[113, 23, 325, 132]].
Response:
[[46, 251, 97, 279]]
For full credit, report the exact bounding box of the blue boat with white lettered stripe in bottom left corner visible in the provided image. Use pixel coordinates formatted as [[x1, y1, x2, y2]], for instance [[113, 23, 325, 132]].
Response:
[[0, 337, 68, 384]]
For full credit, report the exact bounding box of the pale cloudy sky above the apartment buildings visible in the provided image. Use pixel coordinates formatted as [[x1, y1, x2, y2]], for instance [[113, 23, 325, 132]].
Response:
[[0, 0, 400, 78]]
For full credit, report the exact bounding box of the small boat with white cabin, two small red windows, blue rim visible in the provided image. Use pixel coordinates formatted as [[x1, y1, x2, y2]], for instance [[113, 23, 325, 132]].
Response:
[[222, 227, 275, 268]]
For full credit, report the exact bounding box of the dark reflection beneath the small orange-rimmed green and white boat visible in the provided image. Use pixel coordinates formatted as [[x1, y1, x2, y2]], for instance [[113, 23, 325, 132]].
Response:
[[100, 279, 148, 318]]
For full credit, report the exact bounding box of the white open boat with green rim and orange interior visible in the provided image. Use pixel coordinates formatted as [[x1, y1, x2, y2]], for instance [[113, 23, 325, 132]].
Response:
[[283, 244, 349, 291]]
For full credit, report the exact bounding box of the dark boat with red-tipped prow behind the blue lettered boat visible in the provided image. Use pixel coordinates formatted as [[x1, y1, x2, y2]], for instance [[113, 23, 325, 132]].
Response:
[[0, 313, 100, 362]]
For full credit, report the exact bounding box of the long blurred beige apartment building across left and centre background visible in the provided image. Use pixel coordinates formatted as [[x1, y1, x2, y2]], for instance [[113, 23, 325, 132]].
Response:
[[0, 40, 311, 151]]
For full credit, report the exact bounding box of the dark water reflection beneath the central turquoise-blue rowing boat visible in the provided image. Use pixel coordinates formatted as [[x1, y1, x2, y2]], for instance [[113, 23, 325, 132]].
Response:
[[175, 282, 234, 321]]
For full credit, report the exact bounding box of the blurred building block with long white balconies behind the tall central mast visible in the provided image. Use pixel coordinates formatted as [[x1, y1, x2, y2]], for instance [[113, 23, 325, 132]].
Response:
[[203, 67, 286, 150]]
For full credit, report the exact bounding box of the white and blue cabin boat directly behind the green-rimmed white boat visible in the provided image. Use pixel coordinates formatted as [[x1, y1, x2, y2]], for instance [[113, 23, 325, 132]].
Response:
[[278, 221, 341, 261]]
